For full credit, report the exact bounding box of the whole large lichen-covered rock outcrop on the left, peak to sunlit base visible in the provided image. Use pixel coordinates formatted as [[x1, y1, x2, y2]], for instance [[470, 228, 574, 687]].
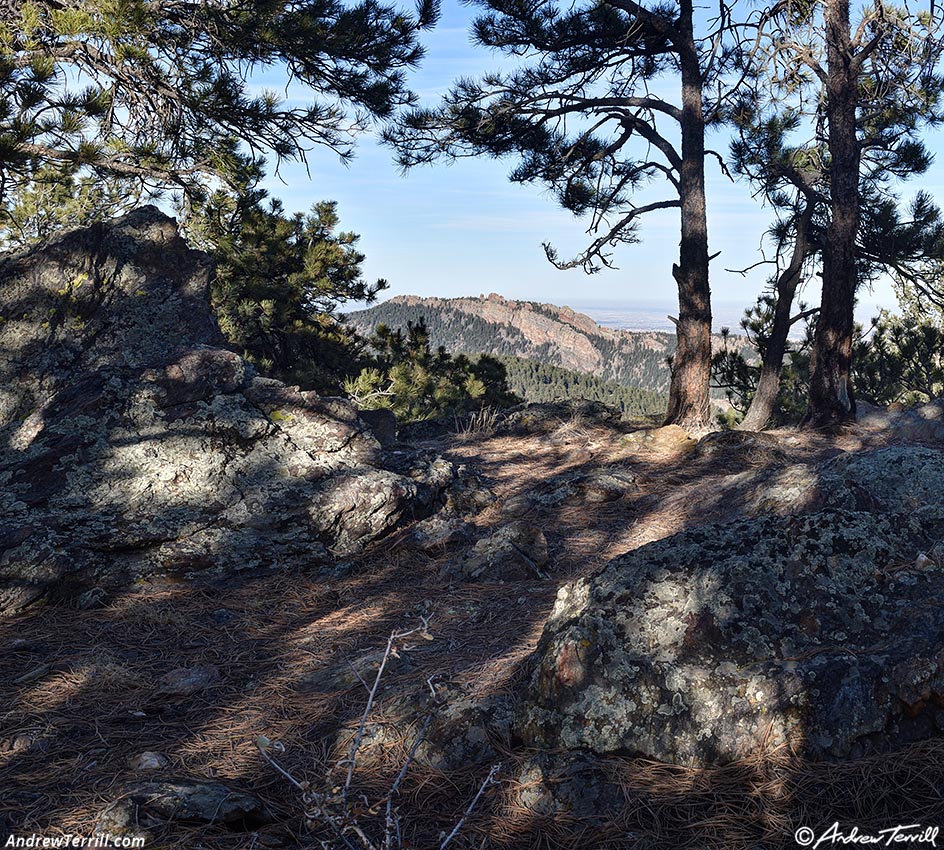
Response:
[[0, 207, 434, 612]]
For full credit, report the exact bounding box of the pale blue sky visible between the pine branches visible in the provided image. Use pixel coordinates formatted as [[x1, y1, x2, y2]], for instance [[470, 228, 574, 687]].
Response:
[[259, 0, 944, 324]]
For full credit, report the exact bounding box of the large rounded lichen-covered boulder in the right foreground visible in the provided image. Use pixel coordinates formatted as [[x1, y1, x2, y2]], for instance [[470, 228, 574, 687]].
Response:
[[516, 506, 944, 765]]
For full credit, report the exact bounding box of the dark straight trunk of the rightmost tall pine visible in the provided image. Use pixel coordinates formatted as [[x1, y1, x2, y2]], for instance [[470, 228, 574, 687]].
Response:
[[805, 0, 860, 428]]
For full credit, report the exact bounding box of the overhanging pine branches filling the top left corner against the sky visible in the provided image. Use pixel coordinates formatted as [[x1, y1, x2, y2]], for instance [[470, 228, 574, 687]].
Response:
[[0, 0, 438, 200]]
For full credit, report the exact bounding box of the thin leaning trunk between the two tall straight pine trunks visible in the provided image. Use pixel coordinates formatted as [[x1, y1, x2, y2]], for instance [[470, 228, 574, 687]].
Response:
[[738, 201, 814, 431]]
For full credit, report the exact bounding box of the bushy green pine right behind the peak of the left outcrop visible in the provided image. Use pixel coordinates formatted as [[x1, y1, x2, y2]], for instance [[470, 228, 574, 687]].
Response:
[[188, 192, 387, 393]]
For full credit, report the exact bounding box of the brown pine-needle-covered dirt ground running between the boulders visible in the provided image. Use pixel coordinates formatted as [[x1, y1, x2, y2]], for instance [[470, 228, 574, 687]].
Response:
[[0, 422, 944, 850]]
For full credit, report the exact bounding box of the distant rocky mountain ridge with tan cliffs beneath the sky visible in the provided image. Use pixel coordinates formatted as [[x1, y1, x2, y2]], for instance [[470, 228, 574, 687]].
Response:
[[347, 294, 745, 393]]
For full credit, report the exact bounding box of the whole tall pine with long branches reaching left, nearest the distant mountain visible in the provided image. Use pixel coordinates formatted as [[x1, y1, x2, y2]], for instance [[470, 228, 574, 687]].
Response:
[[387, 0, 758, 428]]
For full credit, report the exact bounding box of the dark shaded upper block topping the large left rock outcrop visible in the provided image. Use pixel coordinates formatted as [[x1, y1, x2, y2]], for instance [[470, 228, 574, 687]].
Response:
[[0, 202, 223, 425]]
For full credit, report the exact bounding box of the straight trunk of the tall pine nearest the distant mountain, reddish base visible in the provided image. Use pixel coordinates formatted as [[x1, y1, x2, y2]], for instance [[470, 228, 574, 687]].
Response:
[[665, 0, 711, 431]]
